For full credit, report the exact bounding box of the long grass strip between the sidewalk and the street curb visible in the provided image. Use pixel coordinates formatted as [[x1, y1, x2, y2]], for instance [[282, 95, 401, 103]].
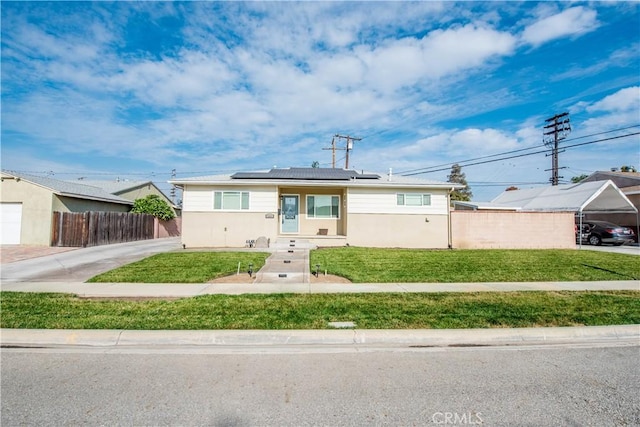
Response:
[[0, 291, 640, 330]]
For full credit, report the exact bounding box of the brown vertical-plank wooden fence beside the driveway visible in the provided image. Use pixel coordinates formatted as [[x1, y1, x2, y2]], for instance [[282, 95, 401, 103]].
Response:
[[51, 212, 154, 247]]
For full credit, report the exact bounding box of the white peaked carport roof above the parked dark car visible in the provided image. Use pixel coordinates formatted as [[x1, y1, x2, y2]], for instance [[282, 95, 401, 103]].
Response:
[[491, 181, 637, 213]]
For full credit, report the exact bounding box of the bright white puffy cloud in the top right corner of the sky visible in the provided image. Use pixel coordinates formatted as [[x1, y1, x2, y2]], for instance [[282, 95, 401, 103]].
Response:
[[522, 6, 599, 46]]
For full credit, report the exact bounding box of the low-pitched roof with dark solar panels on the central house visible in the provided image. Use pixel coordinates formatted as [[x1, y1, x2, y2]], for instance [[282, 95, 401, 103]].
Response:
[[169, 168, 463, 189]]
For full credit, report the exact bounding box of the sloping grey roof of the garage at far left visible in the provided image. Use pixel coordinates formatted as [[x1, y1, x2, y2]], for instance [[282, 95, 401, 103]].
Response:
[[2, 171, 133, 205]]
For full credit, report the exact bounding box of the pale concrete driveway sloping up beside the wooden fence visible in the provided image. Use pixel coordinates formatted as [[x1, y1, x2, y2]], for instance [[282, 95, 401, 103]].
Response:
[[0, 237, 181, 282]]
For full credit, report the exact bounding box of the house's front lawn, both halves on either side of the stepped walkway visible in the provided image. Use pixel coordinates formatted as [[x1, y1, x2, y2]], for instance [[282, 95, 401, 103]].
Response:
[[89, 247, 640, 283]]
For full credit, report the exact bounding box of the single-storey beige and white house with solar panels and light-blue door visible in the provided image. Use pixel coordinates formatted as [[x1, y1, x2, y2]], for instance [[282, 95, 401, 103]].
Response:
[[169, 168, 461, 248]]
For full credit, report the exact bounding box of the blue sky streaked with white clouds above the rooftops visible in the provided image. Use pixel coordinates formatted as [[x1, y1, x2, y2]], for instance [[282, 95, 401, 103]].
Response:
[[1, 1, 640, 201]]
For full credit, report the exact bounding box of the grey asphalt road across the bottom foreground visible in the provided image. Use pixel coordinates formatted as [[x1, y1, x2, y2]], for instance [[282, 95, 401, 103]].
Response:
[[1, 344, 640, 426]]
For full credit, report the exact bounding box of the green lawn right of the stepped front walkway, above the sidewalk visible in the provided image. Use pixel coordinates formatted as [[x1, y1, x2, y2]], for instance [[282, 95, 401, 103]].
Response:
[[310, 247, 640, 283]]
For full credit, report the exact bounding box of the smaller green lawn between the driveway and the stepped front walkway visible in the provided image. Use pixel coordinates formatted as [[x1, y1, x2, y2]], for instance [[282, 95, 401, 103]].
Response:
[[88, 252, 269, 283]]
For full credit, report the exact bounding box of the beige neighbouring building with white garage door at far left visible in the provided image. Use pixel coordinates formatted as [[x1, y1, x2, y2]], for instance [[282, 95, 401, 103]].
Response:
[[0, 171, 133, 246]]
